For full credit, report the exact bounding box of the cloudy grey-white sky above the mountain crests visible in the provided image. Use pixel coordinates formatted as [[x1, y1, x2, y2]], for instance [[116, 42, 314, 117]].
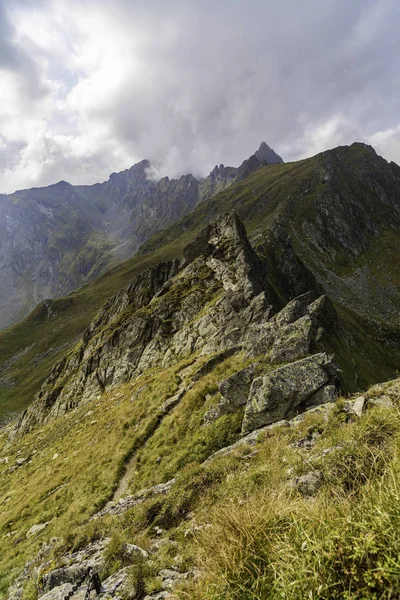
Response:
[[0, 0, 400, 193]]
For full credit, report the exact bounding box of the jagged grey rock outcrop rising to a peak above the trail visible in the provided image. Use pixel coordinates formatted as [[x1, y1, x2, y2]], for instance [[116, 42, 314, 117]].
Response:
[[18, 214, 337, 433]]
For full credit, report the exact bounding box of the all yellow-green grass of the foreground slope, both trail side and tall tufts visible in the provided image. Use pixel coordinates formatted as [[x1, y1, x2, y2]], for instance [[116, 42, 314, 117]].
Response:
[[0, 355, 400, 600]]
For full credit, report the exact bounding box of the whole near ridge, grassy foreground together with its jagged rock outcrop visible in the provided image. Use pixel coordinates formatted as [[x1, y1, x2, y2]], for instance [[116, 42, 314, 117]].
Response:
[[0, 213, 400, 600]]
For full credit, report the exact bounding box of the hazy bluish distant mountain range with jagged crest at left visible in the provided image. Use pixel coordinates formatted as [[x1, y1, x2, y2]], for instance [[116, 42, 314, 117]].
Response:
[[0, 143, 282, 328]]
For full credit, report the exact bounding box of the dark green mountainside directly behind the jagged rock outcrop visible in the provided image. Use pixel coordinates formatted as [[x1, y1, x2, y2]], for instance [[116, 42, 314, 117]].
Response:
[[0, 144, 400, 428]]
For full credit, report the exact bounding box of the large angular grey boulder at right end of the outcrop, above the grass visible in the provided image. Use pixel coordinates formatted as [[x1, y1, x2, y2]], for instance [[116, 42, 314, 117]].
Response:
[[242, 353, 339, 432]]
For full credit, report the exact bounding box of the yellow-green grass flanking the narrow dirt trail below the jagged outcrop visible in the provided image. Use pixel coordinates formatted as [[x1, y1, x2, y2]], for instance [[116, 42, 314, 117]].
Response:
[[0, 356, 250, 593]]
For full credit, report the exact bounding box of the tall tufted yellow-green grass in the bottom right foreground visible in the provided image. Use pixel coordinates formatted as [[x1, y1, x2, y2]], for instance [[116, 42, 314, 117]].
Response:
[[178, 398, 400, 600]]
